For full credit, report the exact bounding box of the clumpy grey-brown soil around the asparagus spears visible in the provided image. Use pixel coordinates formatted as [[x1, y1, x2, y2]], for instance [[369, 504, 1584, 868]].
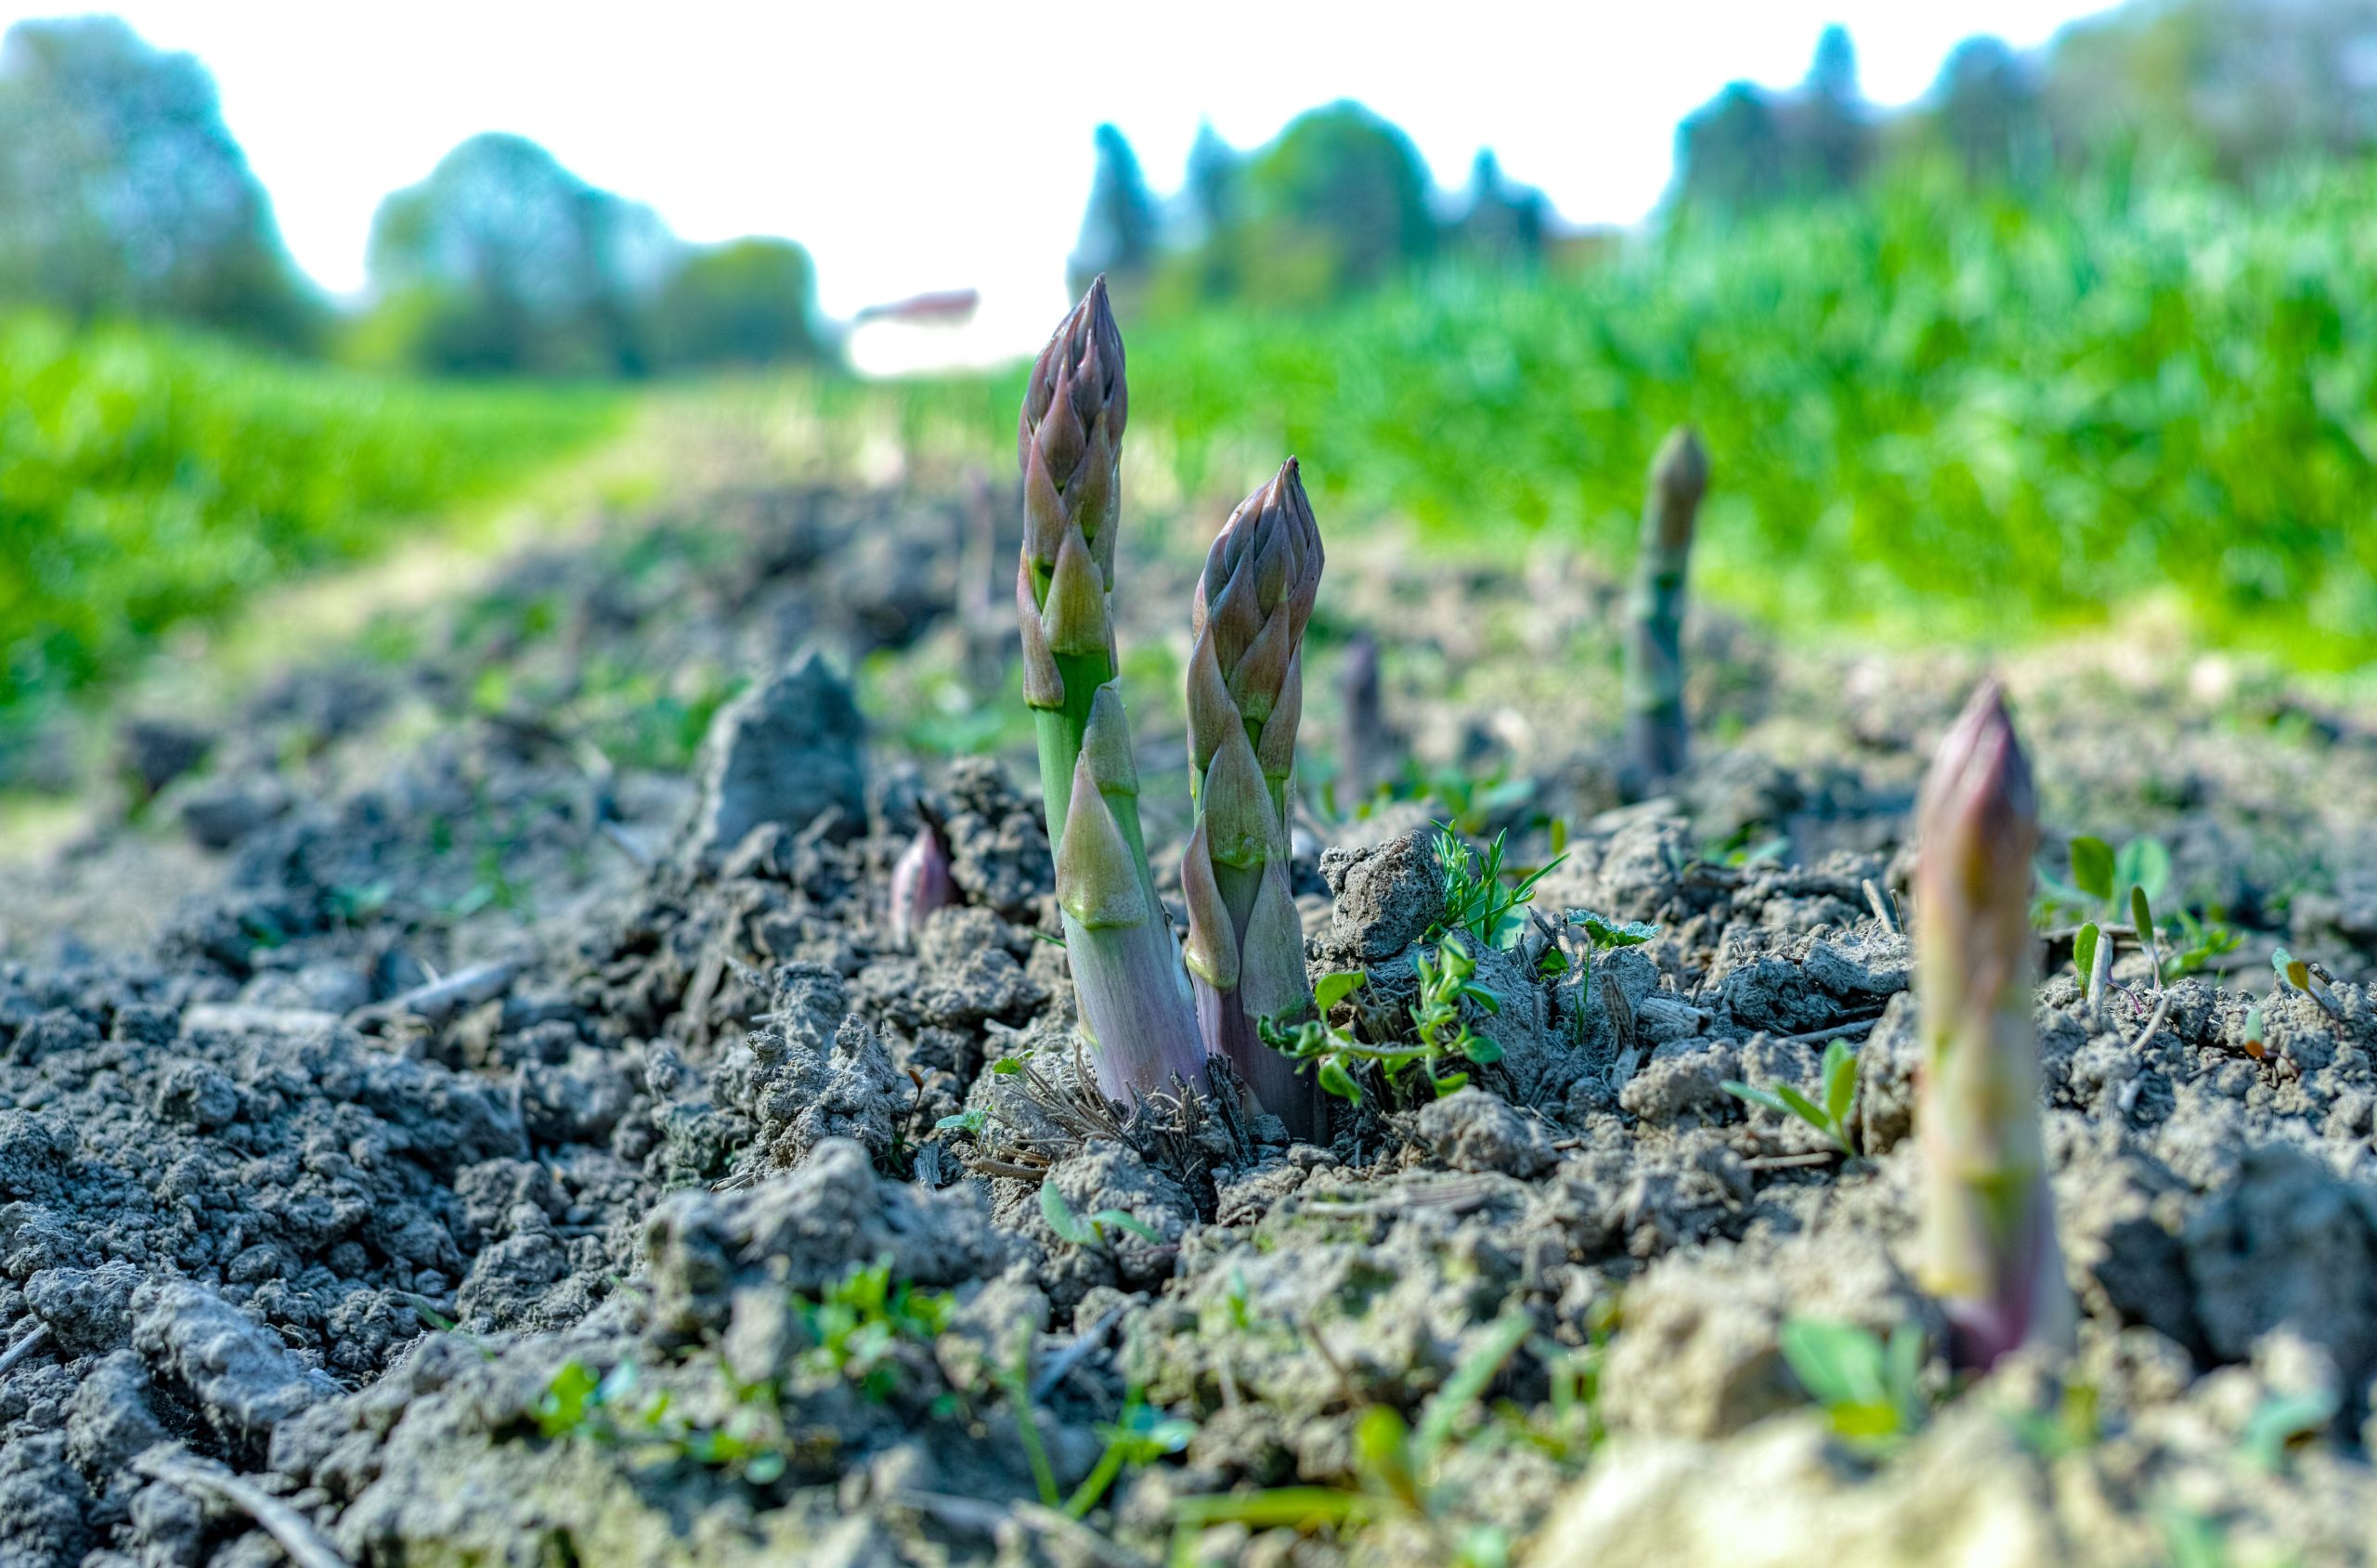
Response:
[[0, 441, 2377, 1568]]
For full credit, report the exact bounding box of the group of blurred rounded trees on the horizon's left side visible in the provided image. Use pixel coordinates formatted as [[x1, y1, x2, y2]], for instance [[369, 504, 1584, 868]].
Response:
[[0, 17, 827, 375]]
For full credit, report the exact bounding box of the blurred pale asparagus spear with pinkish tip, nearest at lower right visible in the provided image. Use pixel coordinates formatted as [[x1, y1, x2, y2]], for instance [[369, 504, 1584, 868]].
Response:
[[1916, 681, 2072, 1368]]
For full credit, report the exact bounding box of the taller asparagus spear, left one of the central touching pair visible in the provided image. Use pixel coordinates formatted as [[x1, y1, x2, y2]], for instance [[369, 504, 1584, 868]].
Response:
[[1015, 278, 1205, 1102]]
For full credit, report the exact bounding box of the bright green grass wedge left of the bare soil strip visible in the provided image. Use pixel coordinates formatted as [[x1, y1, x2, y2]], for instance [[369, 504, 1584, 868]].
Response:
[[0, 314, 625, 734]]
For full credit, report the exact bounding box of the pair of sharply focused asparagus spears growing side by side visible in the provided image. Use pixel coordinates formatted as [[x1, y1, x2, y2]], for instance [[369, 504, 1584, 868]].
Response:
[[1015, 278, 1321, 1138]]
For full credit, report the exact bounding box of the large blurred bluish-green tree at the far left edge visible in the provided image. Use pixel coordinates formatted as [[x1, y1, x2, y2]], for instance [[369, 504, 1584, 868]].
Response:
[[0, 17, 321, 344]]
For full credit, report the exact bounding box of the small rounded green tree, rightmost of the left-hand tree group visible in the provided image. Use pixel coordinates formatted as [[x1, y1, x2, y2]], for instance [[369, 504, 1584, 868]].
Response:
[[649, 240, 823, 370]]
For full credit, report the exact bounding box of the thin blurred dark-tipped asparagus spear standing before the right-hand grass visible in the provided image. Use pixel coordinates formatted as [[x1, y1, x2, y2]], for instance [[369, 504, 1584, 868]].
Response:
[[1626, 425, 1709, 789]]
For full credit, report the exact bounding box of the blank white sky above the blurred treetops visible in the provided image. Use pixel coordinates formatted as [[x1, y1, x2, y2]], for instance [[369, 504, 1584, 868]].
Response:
[[0, 0, 2104, 343]]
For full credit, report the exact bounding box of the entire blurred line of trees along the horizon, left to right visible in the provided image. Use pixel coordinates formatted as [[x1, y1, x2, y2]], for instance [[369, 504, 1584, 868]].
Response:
[[0, 0, 2377, 378]]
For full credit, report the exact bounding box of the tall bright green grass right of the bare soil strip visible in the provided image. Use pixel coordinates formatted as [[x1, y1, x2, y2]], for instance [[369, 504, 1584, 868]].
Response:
[[844, 166, 2377, 666]]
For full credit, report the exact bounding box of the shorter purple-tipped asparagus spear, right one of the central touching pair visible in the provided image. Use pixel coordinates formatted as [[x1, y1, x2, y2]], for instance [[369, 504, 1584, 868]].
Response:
[[1181, 459, 1321, 1138]]
